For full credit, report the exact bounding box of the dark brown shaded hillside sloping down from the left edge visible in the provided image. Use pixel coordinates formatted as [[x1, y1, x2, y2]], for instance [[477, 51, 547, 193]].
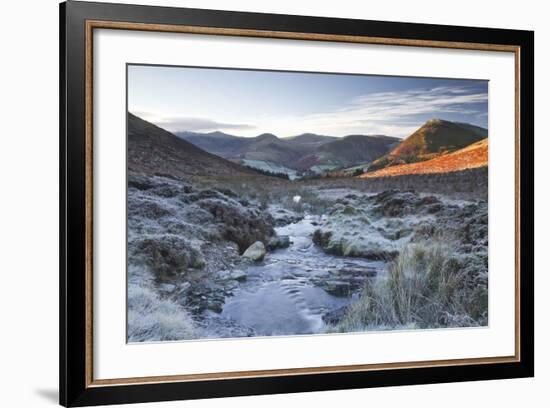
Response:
[[128, 113, 264, 179]]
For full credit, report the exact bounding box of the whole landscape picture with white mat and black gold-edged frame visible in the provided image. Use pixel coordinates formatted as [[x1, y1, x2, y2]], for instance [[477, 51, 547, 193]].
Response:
[[60, 1, 534, 406]]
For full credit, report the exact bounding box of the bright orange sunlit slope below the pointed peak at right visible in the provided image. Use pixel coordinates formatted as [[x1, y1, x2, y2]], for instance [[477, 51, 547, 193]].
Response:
[[360, 138, 489, 178]]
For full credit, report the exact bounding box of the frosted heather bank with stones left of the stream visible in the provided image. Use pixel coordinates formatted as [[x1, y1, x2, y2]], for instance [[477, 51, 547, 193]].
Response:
[[128, 173, 274, 322]]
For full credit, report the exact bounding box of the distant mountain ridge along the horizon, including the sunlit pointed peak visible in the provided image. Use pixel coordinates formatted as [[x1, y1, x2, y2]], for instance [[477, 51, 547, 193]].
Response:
[[177, 119, 488, 177]]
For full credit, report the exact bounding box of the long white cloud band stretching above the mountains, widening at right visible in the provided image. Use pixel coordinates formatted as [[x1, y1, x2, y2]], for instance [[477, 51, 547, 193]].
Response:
[[136, 86, 488, 137]]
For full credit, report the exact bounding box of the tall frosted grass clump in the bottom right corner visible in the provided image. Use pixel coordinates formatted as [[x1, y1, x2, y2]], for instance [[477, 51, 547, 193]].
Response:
[[328, 240, 488, 332]]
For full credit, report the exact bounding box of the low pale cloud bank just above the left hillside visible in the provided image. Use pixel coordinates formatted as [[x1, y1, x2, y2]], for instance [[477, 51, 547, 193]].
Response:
[[134, 112, 255, 132]]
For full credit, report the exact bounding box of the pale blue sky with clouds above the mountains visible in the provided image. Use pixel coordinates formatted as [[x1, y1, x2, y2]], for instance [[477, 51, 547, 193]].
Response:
[[128, 65, 488, 137]]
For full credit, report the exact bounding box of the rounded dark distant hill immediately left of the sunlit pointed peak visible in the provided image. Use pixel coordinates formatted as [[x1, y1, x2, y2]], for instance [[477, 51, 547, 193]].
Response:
[[294, 135, 400, 170]]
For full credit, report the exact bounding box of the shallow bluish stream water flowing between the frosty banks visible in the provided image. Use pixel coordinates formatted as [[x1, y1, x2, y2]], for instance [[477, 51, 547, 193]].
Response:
[[221, 215, 384, 336]]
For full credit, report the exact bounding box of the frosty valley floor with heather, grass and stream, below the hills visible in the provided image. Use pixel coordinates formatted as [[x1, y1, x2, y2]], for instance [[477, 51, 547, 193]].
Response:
[[128, 169, 488, 341]]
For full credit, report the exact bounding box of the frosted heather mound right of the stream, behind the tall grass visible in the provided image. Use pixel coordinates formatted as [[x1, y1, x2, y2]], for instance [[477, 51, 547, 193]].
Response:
[[313, 190, 487, 260]]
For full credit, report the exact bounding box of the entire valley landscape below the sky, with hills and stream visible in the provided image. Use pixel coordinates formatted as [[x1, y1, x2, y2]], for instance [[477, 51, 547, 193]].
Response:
[[127, 114, 488, 342]]
